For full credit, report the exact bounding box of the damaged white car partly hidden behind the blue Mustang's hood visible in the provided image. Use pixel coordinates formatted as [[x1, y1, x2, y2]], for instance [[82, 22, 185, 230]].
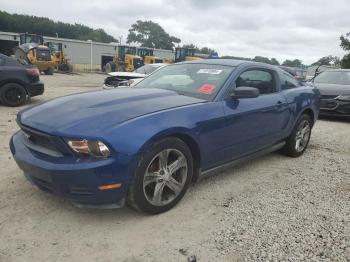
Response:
[[102, 63, 167, 89]]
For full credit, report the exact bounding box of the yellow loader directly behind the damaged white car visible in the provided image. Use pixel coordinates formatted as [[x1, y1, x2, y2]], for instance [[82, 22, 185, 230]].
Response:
[[104, 45, 144, 73]]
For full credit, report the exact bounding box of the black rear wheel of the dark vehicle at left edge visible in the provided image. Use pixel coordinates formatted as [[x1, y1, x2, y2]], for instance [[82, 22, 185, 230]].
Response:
[[0, 83, 27, 107]]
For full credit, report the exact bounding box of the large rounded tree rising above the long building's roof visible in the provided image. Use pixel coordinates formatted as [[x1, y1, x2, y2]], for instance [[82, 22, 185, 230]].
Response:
[[127, 20, 181, 50]]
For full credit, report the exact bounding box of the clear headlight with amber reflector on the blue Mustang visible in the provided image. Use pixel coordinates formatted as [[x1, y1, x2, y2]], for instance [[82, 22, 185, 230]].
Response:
[[66, 139, 110, 157]]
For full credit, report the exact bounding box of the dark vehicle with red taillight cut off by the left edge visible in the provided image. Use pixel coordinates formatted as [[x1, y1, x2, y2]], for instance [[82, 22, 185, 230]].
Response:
[[0, 54, 44, 106]]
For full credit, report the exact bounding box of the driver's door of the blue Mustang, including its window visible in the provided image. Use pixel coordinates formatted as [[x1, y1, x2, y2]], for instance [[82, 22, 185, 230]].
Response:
[[223, 67, 290, 161]]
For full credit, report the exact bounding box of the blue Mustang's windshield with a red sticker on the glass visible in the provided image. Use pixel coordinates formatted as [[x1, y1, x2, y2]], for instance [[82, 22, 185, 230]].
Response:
[[135, 64, 234, 100]]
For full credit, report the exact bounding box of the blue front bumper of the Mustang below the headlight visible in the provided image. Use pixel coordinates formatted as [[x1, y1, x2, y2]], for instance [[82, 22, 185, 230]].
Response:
[[10, 131, 134, 207]]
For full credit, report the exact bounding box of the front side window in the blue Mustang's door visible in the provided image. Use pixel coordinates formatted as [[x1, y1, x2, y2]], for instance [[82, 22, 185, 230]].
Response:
[[236, 69, 276, 94]]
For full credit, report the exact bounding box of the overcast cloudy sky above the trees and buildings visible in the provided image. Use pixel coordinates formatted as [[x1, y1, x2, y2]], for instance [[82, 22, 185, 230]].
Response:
[[0, 0, 350, 64]]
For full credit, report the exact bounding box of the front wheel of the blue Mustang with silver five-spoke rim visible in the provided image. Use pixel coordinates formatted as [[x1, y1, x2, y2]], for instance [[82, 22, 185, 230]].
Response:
[[127, 138, 193, 214]]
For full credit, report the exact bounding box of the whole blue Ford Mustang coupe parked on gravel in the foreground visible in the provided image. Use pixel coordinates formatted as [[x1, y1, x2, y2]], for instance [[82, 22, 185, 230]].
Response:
[[10, 59, 320, 214]]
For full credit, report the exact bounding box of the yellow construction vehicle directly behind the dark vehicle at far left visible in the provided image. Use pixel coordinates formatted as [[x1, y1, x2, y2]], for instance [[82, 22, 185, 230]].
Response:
[[14, 33, 55, 75]]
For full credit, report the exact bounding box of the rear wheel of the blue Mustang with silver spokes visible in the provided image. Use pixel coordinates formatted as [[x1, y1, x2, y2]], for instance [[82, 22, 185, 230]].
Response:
[[282, 114, 313, 157]]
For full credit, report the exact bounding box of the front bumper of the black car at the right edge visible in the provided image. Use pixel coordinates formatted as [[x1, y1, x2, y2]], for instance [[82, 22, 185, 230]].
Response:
[[320, 99, 350, 117]]
